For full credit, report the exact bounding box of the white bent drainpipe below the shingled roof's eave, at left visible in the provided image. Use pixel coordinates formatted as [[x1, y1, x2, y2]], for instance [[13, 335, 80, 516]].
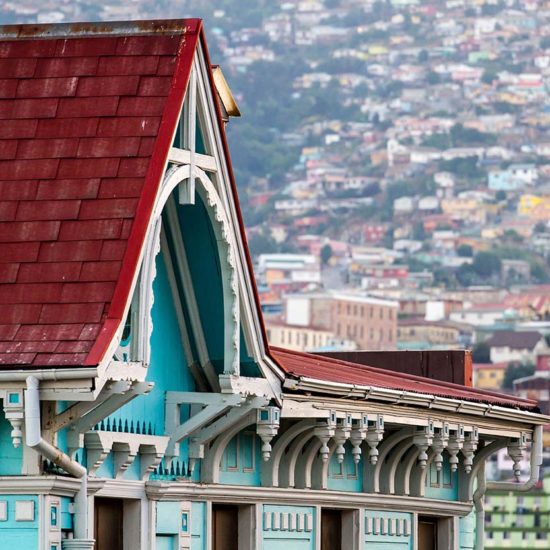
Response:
[[25, 376, 94, 549]]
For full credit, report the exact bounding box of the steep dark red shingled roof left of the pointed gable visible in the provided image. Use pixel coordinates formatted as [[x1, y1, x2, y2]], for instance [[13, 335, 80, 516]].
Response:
[[0, 19, 201, 367]]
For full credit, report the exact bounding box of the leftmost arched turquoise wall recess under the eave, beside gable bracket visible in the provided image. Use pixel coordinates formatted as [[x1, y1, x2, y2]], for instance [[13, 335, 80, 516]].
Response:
[[220, 430, 262, 487]]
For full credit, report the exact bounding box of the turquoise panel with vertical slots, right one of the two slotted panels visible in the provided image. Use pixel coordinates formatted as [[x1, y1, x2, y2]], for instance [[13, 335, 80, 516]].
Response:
[[363, 510, 413, 550]]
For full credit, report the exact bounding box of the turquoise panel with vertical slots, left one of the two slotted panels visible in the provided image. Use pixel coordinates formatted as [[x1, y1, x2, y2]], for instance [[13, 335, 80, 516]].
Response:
[[262, 504, 315, 550]]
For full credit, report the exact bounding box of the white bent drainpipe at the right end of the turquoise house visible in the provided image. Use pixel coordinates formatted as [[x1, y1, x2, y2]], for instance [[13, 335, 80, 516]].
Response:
[[473, 426, 543, 550]]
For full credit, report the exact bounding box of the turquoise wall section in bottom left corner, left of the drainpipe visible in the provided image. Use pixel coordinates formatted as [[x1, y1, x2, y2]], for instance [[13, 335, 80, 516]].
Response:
[[0, 495, 38, 550]]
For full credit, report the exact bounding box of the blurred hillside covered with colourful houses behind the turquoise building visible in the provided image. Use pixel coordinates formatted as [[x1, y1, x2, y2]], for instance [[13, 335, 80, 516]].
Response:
[[6, 0, 550, 548]]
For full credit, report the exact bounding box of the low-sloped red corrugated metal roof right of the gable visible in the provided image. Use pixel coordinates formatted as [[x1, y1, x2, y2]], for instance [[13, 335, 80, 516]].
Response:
[[270, 347, 537, 409]]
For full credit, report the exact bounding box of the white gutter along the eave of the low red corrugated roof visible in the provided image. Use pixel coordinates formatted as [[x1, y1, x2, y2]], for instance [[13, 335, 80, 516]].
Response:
[[283, 377, 550, 424]]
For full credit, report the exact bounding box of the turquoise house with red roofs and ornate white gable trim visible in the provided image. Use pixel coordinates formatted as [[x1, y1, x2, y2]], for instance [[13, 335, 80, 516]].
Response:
[[0, 19, 548, 550]]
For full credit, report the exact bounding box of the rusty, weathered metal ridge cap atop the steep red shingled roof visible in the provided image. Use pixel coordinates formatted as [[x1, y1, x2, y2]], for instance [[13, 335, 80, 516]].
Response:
[[0, 18, 202, 40]]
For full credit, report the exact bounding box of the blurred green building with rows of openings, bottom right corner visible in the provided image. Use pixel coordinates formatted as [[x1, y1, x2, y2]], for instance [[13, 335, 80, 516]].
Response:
[[485, 472, 550, 550]]
